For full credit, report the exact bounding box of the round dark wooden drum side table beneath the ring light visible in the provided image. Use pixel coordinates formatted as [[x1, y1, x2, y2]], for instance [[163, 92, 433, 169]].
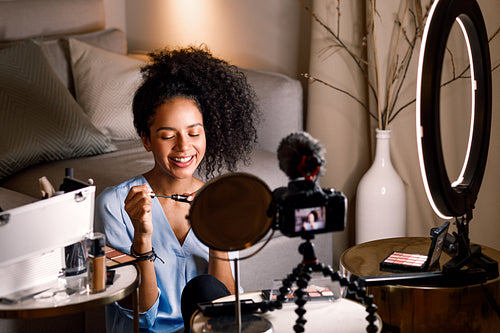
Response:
[[340, 237, 500, 333]]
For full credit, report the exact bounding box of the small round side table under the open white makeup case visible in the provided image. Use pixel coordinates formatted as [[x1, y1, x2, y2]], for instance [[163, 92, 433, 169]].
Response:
[[0, 265, 139, 332]]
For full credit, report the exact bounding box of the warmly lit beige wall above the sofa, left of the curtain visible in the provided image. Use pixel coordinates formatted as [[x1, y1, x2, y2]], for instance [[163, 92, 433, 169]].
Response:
[[105, 0, 310, 78]]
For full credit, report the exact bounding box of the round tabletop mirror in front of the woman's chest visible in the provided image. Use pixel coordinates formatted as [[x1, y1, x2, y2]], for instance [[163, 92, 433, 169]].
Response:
[[189, 173, 272, 251]]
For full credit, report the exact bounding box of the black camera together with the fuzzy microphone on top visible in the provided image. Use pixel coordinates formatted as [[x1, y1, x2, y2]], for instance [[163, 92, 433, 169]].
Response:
[[269, 132, 347, 238]]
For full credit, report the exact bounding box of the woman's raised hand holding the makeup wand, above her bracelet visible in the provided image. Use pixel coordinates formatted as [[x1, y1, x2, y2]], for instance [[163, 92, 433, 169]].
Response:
[[125, 184, 153, 240]]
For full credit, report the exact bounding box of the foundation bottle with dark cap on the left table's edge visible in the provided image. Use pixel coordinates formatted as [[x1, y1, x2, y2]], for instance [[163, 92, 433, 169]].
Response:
[[87, 233, 106, 293]]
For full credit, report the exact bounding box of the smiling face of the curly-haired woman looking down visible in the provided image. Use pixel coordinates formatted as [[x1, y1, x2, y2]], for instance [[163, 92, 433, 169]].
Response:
[[142, 97, 206, 179]]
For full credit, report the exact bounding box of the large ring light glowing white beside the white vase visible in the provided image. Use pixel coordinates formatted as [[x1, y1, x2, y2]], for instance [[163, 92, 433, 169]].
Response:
[[416, 0, 491, 219]]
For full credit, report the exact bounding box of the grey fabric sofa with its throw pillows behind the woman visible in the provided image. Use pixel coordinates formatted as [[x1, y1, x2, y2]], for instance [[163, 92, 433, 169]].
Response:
[[0, 0, 332, 328]]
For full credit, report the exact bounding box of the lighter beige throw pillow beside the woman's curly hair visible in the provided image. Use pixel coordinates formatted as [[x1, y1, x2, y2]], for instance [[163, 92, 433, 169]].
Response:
[[69, 39, 145, 140]]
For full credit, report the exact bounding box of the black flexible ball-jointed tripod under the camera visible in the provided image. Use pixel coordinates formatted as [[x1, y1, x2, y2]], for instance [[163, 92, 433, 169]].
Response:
[[261, 235, 378, 333]]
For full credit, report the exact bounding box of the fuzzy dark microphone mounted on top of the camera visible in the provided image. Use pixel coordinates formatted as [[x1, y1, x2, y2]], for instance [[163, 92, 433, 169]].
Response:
[[277, 132, 326, 180]]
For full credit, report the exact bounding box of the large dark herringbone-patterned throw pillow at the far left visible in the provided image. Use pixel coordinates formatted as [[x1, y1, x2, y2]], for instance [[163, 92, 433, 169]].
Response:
[[0, 41, 116, 180]]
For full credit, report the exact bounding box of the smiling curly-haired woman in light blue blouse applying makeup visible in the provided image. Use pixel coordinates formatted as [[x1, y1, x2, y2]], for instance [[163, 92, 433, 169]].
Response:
[[96, 47, 256, 332]]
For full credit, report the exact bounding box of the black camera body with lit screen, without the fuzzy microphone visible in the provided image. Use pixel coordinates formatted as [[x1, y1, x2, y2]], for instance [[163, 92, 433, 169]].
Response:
[[273, 179, 347, 238]]
